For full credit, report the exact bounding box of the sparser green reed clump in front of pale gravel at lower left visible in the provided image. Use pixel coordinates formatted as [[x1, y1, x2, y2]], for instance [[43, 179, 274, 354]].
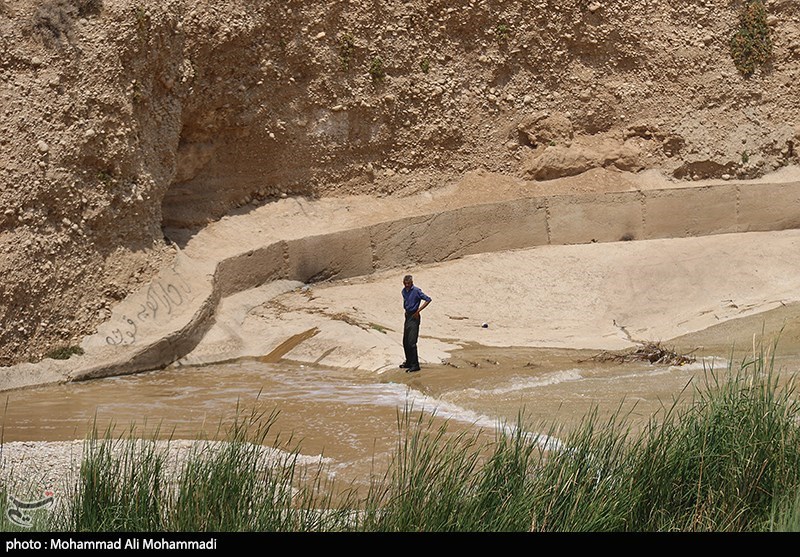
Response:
[[65, 408, 356, 532]]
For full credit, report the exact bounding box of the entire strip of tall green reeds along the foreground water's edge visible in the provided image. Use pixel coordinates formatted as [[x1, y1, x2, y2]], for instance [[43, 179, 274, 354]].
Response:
[[4, 338, 800, 532]]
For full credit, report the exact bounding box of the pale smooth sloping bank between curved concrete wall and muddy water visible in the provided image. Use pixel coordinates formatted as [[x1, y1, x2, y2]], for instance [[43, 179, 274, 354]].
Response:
[[180, 230, 800, 373]]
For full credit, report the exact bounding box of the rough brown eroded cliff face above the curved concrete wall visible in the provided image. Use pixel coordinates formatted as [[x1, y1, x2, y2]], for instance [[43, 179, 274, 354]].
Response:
[[0, 0, 800, 365]]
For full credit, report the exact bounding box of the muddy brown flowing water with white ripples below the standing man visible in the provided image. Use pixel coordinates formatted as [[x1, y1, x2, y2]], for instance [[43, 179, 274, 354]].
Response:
[[2, 347, 764, 479]]
